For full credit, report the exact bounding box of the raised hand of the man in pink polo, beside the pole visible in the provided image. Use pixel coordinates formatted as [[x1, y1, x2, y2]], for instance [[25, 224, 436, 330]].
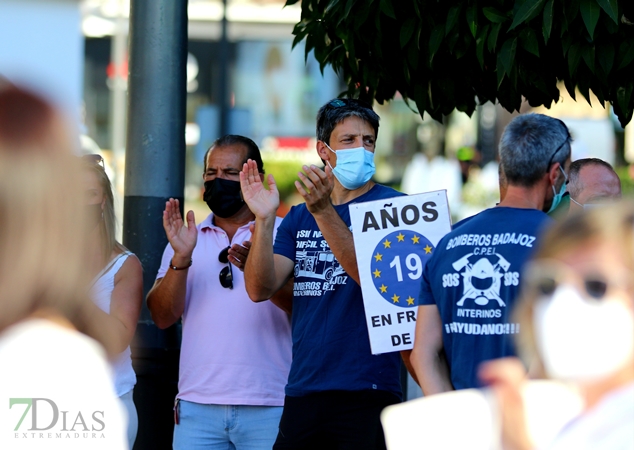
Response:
[[163, 198, 198, 266]]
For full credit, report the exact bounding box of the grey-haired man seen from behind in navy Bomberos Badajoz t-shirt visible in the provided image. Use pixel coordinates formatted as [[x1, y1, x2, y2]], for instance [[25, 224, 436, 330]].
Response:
[[411, 114, 571, 395]]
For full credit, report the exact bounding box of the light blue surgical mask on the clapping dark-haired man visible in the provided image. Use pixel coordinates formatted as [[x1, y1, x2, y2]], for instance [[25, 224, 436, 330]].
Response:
[[324, 142, 376, 191]]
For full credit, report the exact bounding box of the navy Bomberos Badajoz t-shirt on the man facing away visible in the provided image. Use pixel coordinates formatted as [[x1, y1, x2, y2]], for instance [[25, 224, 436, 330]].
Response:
[[419, 207, 552, 389]]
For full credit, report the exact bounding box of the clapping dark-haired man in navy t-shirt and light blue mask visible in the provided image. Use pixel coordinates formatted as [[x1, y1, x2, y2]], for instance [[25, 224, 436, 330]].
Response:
[[240, 99, 409, 449]]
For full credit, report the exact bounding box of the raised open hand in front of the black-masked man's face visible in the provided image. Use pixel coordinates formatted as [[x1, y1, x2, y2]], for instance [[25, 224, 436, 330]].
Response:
[[240, 159, 280, 219]]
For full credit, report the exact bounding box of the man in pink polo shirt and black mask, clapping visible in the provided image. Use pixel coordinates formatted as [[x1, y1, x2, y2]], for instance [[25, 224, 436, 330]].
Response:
[[147, 135, 291, 450]]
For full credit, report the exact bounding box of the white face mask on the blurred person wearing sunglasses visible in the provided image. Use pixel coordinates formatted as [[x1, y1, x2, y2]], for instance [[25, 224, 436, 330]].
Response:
[[533, 284, 634, 382]]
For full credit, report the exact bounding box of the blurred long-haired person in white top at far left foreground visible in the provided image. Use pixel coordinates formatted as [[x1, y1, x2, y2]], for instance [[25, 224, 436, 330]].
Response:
[[0, 85, 128, 449]]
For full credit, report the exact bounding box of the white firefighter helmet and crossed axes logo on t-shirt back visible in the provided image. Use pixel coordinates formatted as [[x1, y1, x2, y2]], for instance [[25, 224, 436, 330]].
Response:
[[452, 253, 511, 306]]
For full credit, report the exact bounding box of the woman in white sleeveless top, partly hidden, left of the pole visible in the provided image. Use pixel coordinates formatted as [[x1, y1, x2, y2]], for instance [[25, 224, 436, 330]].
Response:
[[81, 154, 143, 448]]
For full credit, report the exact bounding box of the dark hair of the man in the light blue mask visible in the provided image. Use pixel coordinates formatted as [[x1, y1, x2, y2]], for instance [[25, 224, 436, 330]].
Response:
[[317, 98, 379, 145]]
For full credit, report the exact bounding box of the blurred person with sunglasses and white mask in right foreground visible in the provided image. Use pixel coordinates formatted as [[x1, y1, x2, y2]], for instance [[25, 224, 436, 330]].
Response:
[[480, 202, 634, 450]]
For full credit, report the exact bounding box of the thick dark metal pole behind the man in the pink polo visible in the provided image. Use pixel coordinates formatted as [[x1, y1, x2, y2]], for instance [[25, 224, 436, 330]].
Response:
[[123, 0, 187, 450]]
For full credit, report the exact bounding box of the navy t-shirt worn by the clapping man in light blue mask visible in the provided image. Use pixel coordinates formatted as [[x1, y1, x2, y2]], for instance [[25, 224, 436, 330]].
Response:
[[274, 184, 403, 397]]
